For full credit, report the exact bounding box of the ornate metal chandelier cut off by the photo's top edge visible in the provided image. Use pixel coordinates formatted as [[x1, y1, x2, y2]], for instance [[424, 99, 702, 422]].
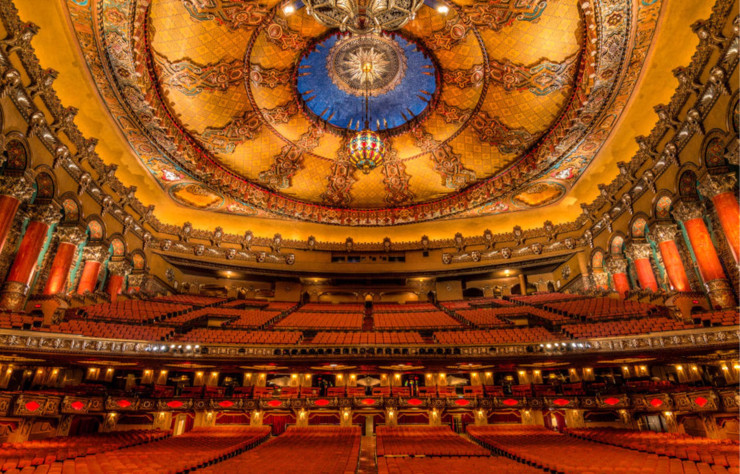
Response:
[[303, 0, 424, 34]]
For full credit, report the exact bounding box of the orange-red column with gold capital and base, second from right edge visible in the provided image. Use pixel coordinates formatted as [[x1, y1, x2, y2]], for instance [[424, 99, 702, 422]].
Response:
[[673, 201, 735, 308]]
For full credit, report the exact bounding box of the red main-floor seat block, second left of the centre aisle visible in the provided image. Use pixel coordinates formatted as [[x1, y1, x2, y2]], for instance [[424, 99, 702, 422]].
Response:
[[28, 426, 270, 474]]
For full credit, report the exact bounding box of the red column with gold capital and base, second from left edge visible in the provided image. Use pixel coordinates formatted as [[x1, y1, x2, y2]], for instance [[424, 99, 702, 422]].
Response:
[[0, 203, 62, 311]]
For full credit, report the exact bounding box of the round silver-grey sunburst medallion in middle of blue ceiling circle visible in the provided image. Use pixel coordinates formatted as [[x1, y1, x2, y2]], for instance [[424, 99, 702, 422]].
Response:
[[326, 35, 406, 97]]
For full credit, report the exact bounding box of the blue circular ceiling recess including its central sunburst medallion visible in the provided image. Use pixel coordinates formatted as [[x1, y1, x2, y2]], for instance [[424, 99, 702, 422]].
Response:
[[296, 33, 437, 131]]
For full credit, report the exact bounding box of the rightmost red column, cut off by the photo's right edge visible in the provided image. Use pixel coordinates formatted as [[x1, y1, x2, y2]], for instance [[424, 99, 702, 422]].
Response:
[[699, 173, 740, 263]]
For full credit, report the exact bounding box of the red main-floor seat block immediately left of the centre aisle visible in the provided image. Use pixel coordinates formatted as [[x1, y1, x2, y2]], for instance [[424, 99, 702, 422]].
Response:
[[197, 427, 360, 474]]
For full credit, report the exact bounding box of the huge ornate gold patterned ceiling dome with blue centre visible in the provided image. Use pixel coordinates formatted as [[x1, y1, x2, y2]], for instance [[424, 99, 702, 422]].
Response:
[[67, 0, 662, 226]]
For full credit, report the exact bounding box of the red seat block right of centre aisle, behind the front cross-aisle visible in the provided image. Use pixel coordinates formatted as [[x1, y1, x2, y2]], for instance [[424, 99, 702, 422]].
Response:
[[376, 426, 491, 456]]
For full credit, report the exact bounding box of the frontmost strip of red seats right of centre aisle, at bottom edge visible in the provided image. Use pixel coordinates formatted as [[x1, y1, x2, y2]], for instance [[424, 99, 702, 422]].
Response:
[[378, 456, 542, 474]]
